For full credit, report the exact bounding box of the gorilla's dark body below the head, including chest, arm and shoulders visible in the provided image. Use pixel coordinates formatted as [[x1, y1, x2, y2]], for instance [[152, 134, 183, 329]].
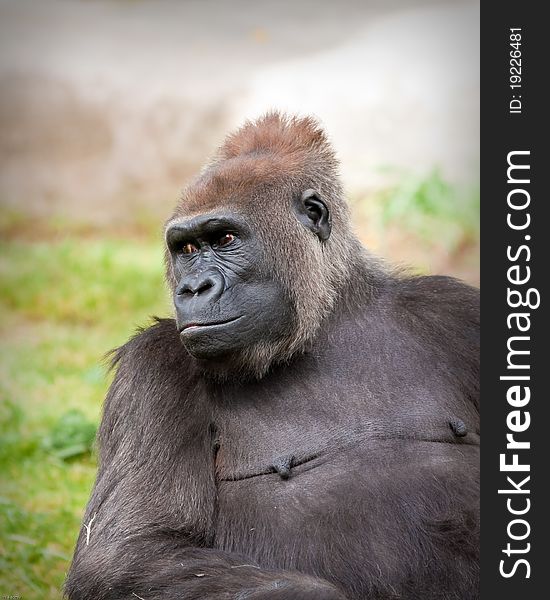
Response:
[[66, 277, 479, 600]]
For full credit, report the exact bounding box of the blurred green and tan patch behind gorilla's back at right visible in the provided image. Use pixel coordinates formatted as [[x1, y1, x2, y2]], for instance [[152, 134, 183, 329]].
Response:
[[351, 167, 479, 285]]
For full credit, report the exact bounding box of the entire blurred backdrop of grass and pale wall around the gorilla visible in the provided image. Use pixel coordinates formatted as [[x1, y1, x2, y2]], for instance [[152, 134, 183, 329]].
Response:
[[0, 0, 479, 599]]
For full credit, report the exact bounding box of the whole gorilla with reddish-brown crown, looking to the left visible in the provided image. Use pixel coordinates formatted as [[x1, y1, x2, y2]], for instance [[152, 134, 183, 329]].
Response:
[[65, 113, 480, 600]]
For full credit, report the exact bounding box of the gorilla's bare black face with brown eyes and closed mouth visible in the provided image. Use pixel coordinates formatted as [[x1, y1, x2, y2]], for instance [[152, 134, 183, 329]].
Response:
[[166, 213, 293, 360]]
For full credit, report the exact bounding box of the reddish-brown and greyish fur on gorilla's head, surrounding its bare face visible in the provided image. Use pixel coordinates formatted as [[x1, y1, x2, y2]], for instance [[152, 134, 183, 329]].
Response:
[[167, 112, 361, 376]]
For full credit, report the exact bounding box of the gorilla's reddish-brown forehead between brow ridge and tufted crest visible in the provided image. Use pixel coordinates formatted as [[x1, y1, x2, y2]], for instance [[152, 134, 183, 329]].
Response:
[[176, 153, 303, 216]]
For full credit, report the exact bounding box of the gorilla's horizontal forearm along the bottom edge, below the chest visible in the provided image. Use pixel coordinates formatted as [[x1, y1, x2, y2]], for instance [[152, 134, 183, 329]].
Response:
[[66, 534, 345, 600]]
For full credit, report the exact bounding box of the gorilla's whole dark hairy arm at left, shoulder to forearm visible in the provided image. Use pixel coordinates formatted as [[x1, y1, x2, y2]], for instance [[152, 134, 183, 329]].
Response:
[[65, 323, 344, 600]]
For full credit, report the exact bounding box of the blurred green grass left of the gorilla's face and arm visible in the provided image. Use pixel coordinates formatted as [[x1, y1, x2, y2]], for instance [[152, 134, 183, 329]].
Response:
[[0, 233, 170, 599]]
